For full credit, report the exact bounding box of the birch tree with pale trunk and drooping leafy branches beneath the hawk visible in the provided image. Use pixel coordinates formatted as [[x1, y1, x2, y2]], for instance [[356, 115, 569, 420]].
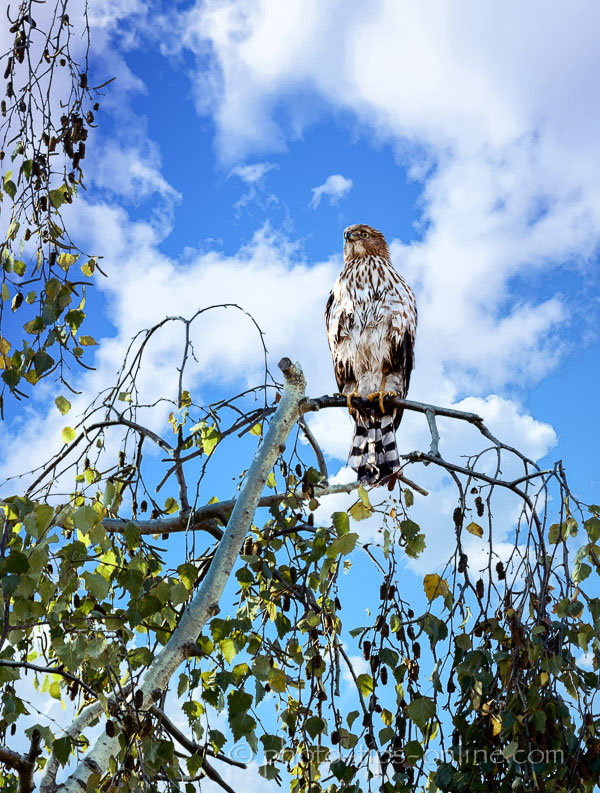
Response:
[[0, 307, 600, 793]]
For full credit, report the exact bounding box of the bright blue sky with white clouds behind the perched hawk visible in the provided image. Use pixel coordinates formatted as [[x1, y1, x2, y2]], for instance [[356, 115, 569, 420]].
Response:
[[1, 0, 600, 784]]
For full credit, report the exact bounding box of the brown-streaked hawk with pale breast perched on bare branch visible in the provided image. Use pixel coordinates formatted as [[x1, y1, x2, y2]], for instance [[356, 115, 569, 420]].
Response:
[[325, 224, 417, 485]]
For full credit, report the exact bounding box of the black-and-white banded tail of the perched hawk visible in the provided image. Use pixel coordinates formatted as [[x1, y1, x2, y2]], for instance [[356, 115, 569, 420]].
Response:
[[348, 408, 402, 485]]
